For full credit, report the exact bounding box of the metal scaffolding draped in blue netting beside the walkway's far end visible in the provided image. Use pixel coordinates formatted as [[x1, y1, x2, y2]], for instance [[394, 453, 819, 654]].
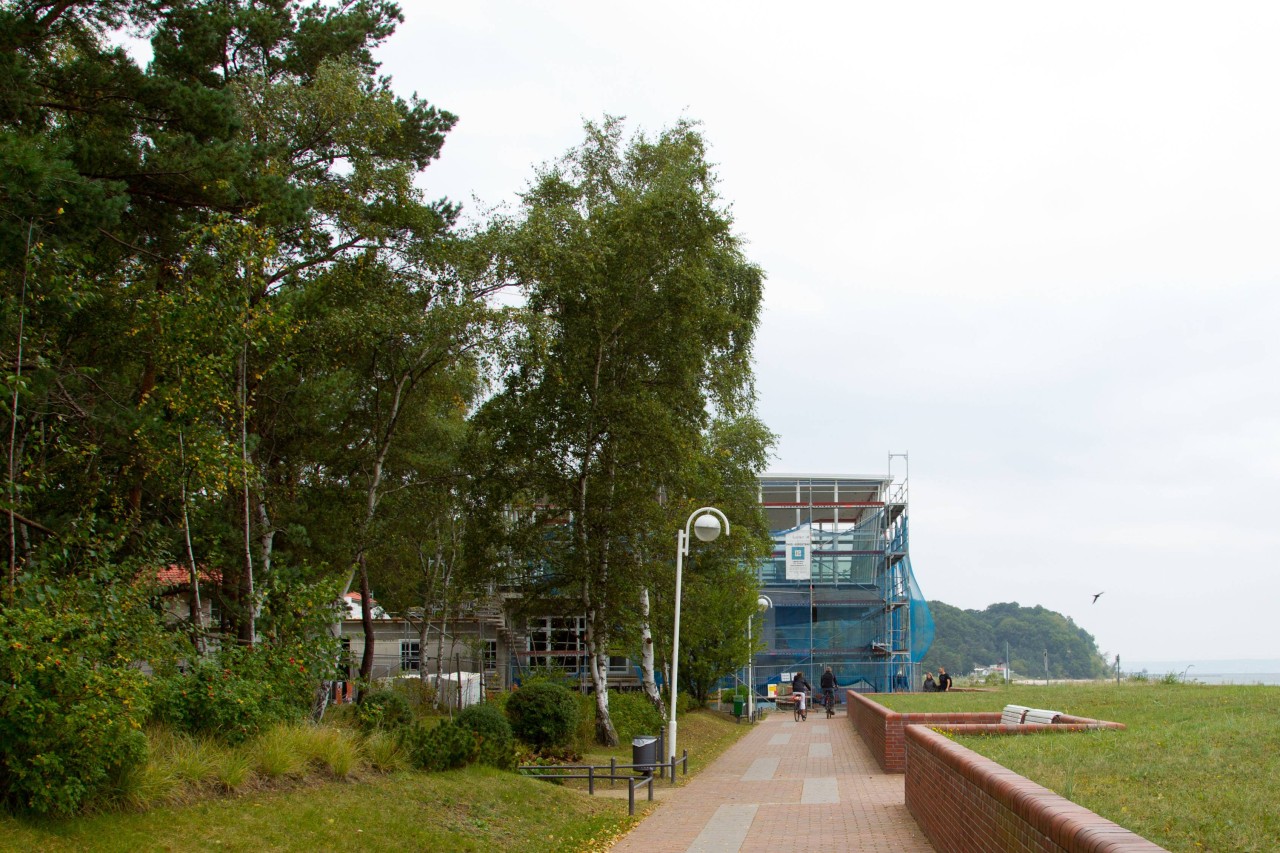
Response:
[[753, 453, 933, 695]]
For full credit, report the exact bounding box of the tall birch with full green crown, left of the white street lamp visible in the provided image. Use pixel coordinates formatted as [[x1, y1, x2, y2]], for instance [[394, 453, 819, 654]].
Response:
[[476, 118, 763, 744]]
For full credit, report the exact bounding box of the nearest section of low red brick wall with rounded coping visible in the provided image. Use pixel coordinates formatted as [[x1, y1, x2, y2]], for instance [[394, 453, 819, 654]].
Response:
[[905, 726, 1164, 853]]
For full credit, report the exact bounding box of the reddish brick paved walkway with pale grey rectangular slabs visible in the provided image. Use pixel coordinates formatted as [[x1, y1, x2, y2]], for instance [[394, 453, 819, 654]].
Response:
[[613, 711, 933, 853]]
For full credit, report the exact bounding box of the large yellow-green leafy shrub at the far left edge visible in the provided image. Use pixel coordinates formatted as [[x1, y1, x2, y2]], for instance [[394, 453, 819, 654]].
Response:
[[0, 581, 159, 813]]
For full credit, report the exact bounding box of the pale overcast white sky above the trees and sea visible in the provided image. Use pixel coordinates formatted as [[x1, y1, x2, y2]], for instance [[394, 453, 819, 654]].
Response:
[[380, 0, 1280, 660]]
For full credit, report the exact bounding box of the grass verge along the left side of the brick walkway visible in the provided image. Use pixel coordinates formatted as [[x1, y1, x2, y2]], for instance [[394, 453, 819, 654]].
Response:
[[0, 712, 748, 853]]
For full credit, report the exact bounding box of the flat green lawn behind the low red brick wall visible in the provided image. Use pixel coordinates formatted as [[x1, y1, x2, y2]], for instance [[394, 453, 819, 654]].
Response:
[[876, 683, 1280, 852]]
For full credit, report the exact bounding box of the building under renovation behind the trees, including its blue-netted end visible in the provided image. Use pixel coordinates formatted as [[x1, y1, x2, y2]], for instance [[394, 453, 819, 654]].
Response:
[[343, 466, 933, 697]]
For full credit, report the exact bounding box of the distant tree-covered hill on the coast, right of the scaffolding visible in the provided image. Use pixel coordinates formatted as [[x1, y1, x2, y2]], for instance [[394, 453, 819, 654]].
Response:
[[924, 601, 1107, 679]]
